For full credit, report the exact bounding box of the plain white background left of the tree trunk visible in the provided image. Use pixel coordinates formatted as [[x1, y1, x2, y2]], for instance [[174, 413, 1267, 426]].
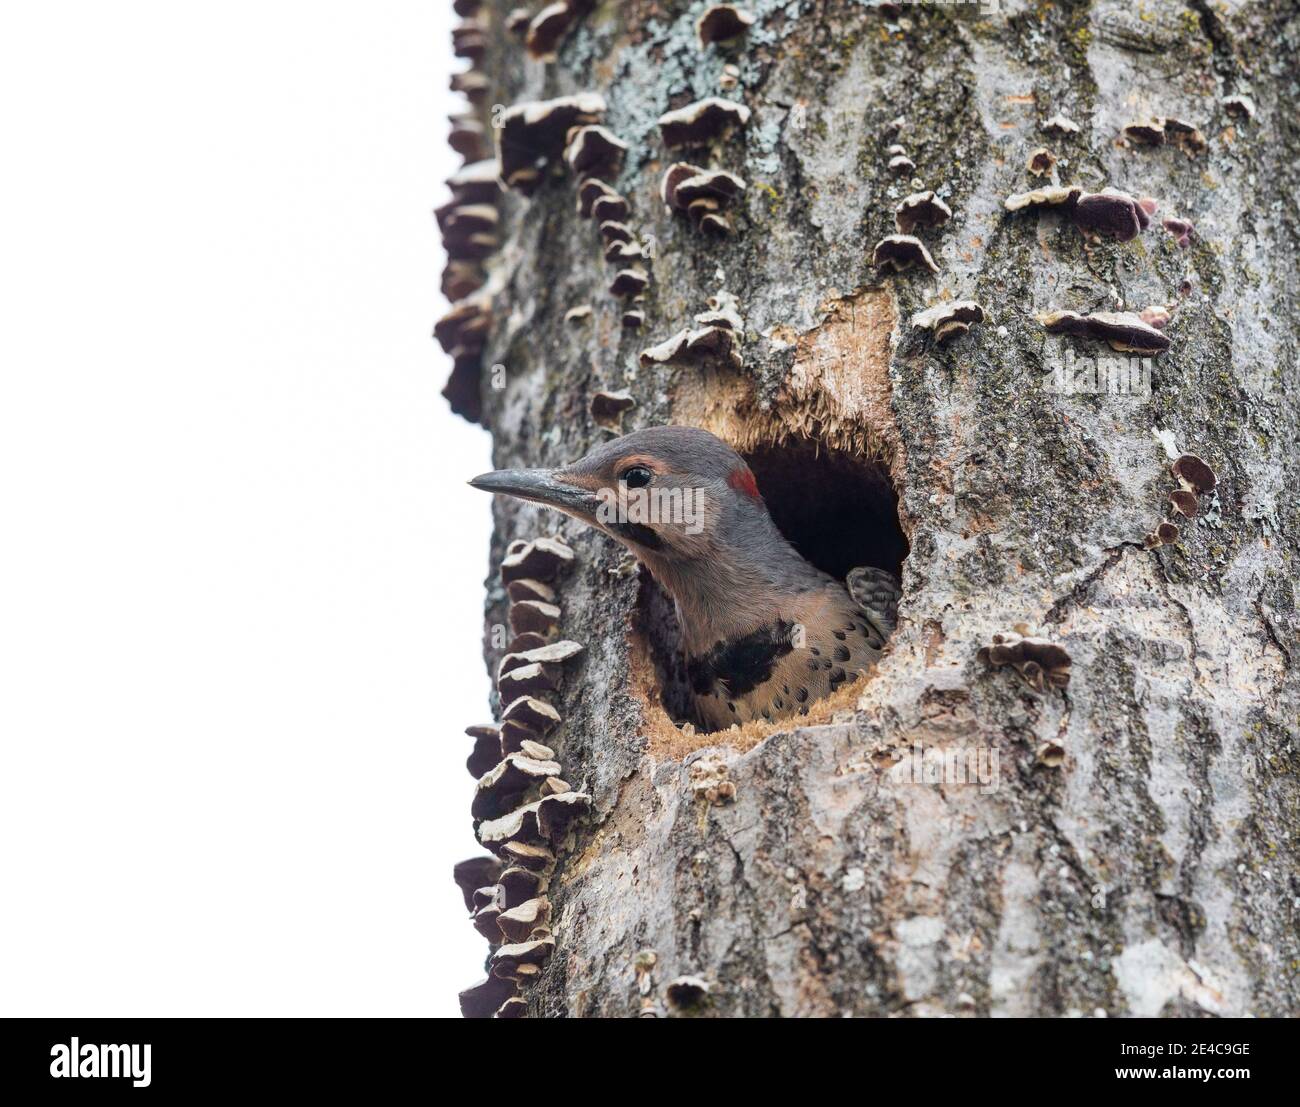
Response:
[[0, 0, 490, 1016]]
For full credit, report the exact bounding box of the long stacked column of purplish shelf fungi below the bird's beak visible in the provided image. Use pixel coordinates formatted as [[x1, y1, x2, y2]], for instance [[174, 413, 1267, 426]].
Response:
[[452, 537, 590, 1019]]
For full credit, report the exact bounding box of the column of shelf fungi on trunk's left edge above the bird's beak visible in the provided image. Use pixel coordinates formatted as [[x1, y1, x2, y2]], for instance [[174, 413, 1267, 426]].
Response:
[[433, 16, 501, 422]]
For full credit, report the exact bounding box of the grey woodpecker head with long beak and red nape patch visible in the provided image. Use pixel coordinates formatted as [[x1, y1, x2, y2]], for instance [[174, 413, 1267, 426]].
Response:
[[469, 426, 770, 568]]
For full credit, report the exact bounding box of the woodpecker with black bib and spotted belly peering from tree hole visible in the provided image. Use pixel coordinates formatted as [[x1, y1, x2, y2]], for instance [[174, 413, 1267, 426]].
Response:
[[469, 426, 901, 730]]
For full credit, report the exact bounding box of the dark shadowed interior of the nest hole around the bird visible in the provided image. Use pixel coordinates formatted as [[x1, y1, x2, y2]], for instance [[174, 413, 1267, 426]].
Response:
[[637, 439, 909, 724]]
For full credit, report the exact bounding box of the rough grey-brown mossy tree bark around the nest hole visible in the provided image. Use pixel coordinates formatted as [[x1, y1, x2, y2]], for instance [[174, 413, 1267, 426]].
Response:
[[449, 0, 1300, 1016]]
